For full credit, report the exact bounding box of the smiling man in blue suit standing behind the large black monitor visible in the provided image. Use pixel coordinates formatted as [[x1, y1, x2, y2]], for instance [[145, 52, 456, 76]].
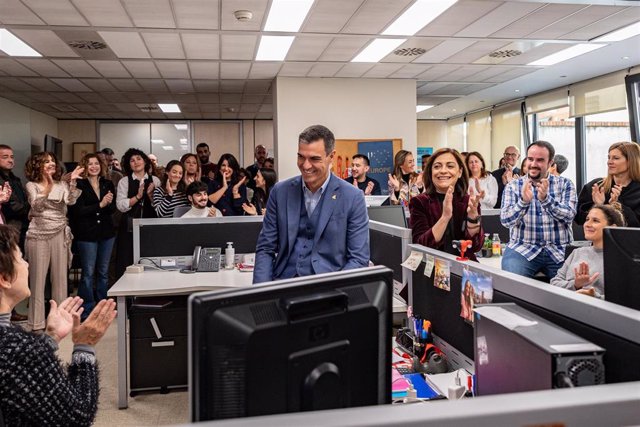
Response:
[[253, 125, 369, 283]]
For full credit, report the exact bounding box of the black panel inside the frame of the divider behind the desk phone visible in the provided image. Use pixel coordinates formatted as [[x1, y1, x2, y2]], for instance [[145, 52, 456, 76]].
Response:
[[140, 221, 262, 258]]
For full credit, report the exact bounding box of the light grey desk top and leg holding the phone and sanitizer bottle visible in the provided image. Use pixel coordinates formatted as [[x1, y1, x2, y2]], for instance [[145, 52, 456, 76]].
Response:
[[108, 270, 253, 409]]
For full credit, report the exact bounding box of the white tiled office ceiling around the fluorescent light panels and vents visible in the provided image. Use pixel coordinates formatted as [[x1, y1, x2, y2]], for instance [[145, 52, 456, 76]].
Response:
[[0, 0, 640, 119]]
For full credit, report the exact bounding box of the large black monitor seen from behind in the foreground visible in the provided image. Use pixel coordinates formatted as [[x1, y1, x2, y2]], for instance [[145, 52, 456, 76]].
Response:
[[189, 267, 393, 422]]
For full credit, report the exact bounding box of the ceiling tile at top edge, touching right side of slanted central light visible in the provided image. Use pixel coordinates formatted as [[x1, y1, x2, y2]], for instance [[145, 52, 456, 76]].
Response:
[[416, 0, 503, 37]]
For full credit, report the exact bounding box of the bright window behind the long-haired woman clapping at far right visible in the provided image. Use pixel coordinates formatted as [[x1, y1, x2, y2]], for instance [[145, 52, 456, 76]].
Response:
[[584, 109, 631, 182]]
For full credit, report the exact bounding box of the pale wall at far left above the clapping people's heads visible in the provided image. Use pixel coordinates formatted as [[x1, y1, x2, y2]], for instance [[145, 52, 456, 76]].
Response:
[[0, 98, 58, 178]]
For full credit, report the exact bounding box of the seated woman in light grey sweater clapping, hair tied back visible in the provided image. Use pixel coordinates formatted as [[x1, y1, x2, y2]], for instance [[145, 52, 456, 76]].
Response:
[[551, 204, 625, 298]]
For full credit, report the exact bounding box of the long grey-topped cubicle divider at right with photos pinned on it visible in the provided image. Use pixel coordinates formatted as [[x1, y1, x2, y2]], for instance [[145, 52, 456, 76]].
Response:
[[409, 245, 640, 383]]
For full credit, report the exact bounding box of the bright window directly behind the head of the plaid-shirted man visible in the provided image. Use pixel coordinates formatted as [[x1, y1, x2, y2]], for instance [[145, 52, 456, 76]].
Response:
[[536, 107, 577, 183]]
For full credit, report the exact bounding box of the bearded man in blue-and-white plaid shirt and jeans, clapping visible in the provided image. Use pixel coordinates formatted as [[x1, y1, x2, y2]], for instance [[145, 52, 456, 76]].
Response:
[[500, 141, 578, 279]]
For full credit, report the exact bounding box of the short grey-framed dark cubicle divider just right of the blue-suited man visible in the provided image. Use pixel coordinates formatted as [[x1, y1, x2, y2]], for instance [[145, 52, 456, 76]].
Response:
[[369, 220, 412, 305]]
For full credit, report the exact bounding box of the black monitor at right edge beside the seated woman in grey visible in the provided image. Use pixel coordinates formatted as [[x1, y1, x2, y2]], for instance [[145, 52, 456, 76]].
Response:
[[604, 227, 640, 310]]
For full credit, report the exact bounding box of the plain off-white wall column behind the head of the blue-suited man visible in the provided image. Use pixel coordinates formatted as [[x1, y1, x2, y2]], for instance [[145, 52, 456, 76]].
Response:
[[274, 77, 417, 179]]
